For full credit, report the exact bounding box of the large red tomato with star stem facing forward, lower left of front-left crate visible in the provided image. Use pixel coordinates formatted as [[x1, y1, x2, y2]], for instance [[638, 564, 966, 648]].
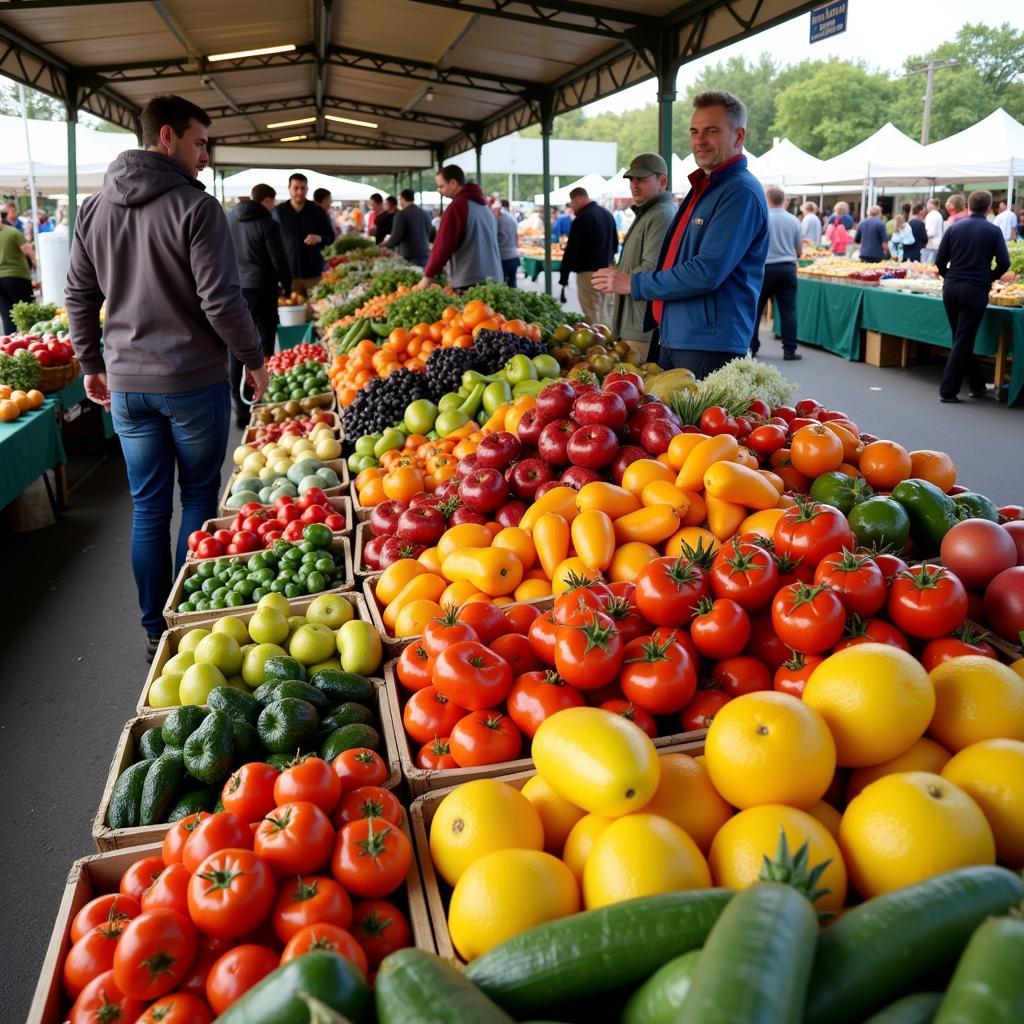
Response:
[[114, 909, 197, 999]]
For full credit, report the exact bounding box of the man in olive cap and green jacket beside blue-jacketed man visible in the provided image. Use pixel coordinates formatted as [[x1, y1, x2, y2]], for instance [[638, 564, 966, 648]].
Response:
[[611, 153, 676, 365]]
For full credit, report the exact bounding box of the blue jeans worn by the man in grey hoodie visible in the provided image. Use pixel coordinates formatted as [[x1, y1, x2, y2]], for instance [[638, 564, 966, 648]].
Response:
[[111, 381, 231, 636]]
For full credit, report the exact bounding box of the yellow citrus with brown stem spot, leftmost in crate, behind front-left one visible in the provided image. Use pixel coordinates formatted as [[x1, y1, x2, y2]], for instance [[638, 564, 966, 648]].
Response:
[[430, 778, 544, 886]]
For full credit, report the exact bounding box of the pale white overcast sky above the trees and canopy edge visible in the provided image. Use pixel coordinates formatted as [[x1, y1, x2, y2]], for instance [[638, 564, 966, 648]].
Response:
[[585, 0, 1024, 114]]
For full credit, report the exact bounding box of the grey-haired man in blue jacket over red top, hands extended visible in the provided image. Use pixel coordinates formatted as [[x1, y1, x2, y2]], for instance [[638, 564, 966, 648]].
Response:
[[593, 92, 768, 378]]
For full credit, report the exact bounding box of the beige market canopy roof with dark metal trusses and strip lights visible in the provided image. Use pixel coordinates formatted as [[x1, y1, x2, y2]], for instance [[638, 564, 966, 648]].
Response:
[[0, 0, 815, 173]]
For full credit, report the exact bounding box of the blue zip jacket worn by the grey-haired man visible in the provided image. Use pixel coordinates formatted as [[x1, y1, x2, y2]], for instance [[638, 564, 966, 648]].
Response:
[[631, 157, 768, 355]]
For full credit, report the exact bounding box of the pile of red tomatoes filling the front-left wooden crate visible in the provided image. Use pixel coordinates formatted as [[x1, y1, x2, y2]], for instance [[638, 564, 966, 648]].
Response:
[[63, 749, 413, 1024]]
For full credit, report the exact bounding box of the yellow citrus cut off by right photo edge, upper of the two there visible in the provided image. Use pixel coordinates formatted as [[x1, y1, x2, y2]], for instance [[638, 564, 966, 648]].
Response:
[[928, 654, 1024, 754]]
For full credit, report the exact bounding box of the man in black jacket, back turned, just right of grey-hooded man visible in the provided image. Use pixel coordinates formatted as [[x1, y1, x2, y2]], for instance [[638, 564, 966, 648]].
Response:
[[227, 184, 292, 427]]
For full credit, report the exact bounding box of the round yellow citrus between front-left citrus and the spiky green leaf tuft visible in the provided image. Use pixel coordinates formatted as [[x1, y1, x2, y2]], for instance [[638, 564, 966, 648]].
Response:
[[583, 814, 711, 909]]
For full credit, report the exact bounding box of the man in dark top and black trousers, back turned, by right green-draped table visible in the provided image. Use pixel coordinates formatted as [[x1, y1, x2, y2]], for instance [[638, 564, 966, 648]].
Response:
[[935, 189, 1010, 402]]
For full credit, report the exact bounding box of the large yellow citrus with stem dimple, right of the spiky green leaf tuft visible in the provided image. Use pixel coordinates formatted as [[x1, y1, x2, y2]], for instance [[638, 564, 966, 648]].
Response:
[[839, 771, 995, 899]]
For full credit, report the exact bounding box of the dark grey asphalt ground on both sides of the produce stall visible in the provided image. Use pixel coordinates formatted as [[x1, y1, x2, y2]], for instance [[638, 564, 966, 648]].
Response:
[[0, 315, 1024, 1021]]
